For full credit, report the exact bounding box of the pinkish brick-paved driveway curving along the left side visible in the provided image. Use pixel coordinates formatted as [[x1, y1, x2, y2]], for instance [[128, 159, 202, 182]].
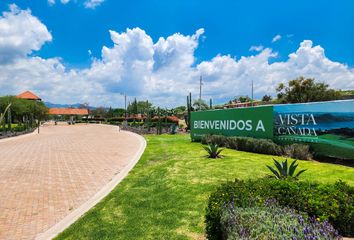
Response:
[[0, 125, 140, 240]]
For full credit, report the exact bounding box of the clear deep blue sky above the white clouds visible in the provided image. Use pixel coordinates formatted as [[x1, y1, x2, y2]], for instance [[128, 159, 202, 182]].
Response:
[[5, 0, 354, 67]]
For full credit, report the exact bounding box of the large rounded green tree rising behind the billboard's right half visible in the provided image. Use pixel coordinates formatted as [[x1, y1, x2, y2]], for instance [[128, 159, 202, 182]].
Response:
[[276, 77, 340, 103]]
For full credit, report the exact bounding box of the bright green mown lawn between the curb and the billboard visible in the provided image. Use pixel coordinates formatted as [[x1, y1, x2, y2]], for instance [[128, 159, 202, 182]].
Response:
[[57, 135, 354, 239]]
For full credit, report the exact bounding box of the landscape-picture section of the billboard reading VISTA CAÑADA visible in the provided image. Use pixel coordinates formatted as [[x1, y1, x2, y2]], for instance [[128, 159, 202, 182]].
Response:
[[273, 100, 354, 159]]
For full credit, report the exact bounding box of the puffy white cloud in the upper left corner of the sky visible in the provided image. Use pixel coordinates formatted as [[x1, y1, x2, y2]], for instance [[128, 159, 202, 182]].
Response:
[[0, 4, 52, 63]]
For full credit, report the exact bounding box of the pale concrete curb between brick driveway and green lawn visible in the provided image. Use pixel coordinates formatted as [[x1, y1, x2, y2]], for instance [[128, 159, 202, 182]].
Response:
[[36, 131, 146, 240]]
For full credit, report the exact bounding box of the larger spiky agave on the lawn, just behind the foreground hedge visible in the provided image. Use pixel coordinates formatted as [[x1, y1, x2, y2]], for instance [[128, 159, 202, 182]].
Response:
[[267, 158, 307, 179]]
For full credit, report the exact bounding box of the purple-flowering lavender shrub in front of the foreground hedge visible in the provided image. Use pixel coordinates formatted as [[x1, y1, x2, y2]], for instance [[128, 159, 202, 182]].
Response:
[[220, 201, 340, 240]]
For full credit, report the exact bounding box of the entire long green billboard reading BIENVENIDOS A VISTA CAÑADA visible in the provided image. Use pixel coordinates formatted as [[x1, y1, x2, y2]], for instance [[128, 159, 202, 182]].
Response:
[[191, 100, 354, 159]]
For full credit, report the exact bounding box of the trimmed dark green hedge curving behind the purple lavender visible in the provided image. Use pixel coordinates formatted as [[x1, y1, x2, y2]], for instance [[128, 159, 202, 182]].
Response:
[[205, 178, 354, 240]]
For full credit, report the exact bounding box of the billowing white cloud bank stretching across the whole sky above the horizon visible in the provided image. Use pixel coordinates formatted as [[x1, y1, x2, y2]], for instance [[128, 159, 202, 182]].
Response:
[[0, 5, 354, 106]]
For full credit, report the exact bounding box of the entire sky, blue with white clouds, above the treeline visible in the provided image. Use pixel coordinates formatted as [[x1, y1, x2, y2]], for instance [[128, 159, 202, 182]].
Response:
[[0, 0, 354, 107]]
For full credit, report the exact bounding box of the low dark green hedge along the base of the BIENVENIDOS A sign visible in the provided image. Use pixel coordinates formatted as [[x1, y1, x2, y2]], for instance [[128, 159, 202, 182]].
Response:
[[202, 135, 283, 156]]
